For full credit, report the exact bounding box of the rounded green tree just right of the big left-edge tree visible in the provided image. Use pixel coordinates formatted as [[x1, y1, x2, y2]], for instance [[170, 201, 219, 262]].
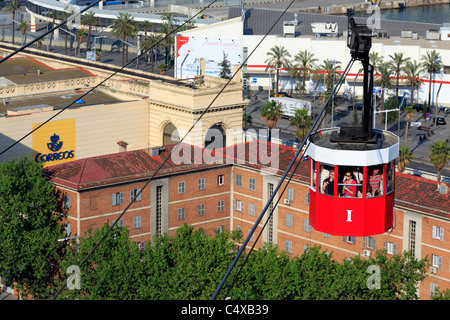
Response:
[[58, 224, 145, 300]]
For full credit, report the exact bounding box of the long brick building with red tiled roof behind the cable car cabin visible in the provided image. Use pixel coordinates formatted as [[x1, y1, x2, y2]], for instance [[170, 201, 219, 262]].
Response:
[[47, 141, 450, 299]]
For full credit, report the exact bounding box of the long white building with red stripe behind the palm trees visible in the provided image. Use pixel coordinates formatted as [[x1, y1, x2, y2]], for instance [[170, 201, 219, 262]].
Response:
[[177, 8, 450, 106]]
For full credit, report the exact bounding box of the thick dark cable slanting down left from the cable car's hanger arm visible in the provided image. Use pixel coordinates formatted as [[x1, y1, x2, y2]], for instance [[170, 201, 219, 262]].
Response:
[[211, 58, 355, 300]]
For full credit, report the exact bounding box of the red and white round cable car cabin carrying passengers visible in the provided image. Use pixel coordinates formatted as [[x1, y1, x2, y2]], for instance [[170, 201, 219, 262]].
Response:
[[307, 128, 399, 237]]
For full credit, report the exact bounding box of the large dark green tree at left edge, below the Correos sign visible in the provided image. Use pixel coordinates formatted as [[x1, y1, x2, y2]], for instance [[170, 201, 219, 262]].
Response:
[[0, 157, 65, 299]]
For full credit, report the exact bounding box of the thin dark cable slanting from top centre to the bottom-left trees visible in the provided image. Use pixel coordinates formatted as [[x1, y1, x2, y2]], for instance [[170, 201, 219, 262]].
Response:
[[50, 0, 294, 300]]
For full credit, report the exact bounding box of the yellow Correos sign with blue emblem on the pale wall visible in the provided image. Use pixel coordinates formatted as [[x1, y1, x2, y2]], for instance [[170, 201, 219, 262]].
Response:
[[33, 119, 76, 167]]
